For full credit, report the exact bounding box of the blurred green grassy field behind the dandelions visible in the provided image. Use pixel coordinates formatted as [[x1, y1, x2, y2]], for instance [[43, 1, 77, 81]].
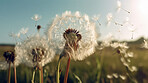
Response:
[[0, 38, 148, 83]]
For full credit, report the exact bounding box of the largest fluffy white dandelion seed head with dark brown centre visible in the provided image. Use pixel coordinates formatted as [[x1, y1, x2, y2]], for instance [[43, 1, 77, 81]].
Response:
[[46, 12, 97, 60]]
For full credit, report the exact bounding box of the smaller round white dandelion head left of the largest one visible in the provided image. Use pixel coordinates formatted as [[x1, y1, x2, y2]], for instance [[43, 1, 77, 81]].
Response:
[[16, 34, 54, 67]]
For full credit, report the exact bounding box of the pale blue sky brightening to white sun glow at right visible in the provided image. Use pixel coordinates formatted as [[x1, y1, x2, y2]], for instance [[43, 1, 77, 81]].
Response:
[[0, 0, 148, 43]]
